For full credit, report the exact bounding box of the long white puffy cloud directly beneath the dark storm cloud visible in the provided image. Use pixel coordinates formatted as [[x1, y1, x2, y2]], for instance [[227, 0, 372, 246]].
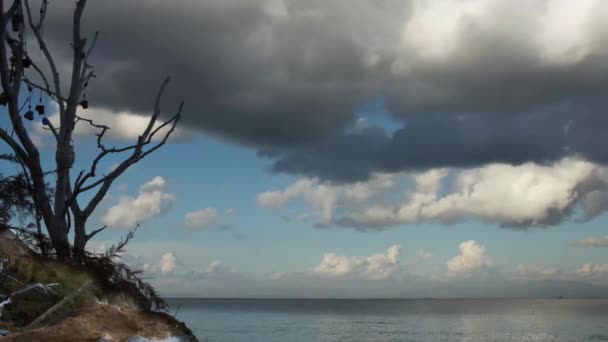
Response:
[[258, 158, 608, 229]]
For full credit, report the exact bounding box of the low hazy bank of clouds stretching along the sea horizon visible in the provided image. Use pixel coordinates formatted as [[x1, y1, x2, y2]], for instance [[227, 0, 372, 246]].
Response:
[[137, 240, 608, 298]]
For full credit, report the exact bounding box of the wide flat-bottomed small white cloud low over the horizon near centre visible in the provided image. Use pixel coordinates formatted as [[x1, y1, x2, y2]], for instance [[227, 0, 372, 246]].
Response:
[[312, 245, 401, 280]]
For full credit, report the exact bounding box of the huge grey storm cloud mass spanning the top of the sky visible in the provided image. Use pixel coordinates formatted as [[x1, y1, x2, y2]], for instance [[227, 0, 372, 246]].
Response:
[[33, 0, 608, 182]]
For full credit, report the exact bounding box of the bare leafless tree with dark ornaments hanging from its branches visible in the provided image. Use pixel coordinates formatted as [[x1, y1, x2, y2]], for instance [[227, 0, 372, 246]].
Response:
[[0, 0, 183, 259]]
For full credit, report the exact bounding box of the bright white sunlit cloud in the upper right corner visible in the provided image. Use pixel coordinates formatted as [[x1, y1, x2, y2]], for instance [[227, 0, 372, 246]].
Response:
[[394, 0, 608, 65]]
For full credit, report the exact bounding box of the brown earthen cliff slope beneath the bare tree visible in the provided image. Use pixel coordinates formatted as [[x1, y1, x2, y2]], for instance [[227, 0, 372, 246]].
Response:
[[0, 230, 197, 342]]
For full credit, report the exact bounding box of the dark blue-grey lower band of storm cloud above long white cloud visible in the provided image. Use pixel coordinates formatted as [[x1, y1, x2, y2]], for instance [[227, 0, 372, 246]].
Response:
[[268, 105, 608, 182]]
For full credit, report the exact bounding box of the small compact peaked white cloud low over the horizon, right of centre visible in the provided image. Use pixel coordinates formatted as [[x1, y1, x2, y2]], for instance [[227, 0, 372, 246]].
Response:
[[446, 240, 493, 278]]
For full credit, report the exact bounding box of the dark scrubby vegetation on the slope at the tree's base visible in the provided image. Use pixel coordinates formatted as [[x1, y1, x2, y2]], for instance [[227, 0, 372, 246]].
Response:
[[0, 229, 166, 330]]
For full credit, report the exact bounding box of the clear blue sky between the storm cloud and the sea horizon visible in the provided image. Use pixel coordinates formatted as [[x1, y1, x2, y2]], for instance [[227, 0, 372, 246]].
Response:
[[8, 107, 607, 297]]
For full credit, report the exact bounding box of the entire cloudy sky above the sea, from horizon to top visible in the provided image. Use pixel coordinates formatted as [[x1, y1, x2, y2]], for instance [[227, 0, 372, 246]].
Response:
[[2, 0, 608, 298]]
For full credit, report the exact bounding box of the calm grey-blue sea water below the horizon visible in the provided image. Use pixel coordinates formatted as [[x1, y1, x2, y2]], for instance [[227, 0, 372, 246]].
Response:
[[169, 299, 608, 342]]
